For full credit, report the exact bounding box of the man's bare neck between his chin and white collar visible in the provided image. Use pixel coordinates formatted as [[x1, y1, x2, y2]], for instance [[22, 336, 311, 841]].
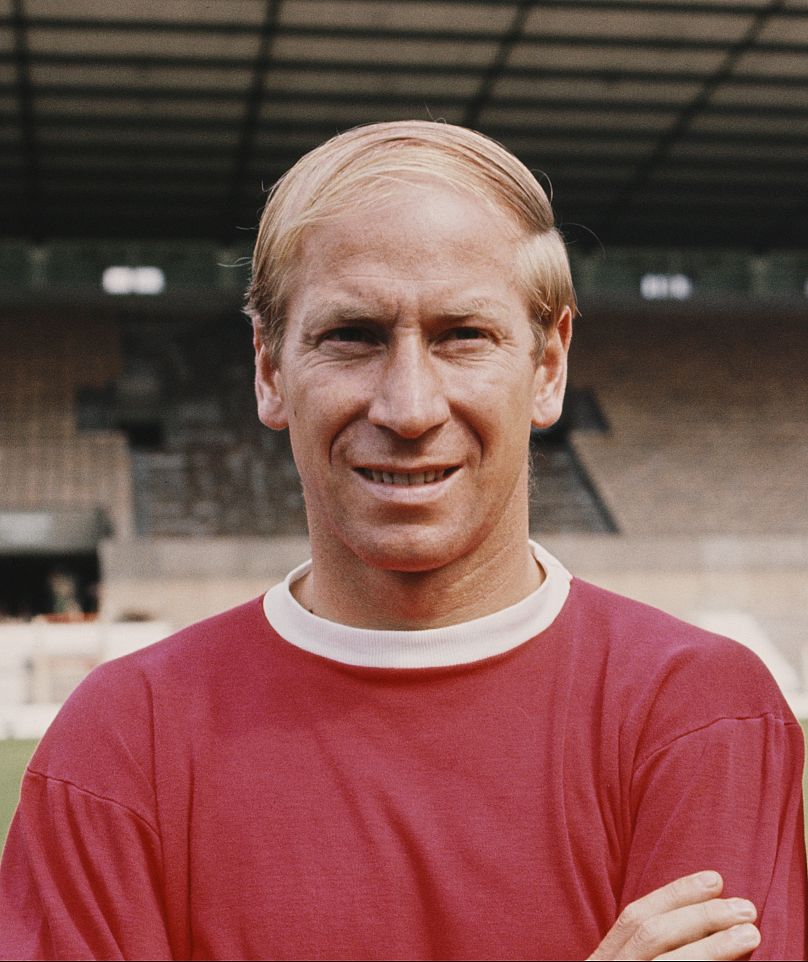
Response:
[[292, 502, 544, 630]]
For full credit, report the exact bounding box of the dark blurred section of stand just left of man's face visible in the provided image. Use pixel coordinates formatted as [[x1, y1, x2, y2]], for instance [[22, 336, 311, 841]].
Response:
[[119, 315, 306, 536]]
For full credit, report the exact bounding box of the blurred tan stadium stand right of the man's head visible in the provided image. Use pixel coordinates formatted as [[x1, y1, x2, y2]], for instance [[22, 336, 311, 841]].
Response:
[[573, 304, 808, 537]]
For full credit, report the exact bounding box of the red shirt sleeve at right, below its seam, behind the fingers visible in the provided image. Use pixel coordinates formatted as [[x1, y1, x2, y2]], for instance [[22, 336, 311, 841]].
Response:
[[621, 714, 808, 959]]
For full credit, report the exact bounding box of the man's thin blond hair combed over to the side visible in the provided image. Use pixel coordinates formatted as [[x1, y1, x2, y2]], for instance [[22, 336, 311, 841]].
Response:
[[246, 120, 576, 363]]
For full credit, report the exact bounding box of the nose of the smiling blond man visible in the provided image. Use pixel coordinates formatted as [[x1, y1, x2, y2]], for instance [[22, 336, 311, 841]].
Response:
[[368, 336, 449, 438]]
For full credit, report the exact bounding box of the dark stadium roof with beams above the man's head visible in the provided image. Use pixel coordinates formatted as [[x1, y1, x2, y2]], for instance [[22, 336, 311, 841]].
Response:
[[0, 0, 808, 251]]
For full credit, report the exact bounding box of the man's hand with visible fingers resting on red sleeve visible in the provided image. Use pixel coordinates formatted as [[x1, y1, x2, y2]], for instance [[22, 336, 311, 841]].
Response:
[[589, 872, 760, 962]]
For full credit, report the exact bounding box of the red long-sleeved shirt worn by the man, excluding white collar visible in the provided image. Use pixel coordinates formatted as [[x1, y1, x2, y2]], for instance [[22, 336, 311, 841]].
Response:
[[0, 580, 806, 959]]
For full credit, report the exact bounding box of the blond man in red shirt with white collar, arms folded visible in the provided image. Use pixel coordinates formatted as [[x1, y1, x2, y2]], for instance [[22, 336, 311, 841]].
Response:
[[0, 122, 806, 959]]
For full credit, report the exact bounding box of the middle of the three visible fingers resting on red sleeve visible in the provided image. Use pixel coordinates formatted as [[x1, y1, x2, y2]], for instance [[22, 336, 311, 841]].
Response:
[[617, 899, 757, 959]]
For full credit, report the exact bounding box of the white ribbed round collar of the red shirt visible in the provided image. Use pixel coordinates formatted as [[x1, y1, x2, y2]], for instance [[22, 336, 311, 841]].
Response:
[[264, 541, 571, 668]]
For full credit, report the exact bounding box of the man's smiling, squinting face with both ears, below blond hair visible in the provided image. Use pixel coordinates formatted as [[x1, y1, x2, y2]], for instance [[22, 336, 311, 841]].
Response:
[[256, 183, 569, 571]]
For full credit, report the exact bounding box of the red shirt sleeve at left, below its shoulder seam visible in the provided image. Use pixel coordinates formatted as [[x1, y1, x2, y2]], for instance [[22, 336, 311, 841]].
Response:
[[0, 769, 172, 960]]
